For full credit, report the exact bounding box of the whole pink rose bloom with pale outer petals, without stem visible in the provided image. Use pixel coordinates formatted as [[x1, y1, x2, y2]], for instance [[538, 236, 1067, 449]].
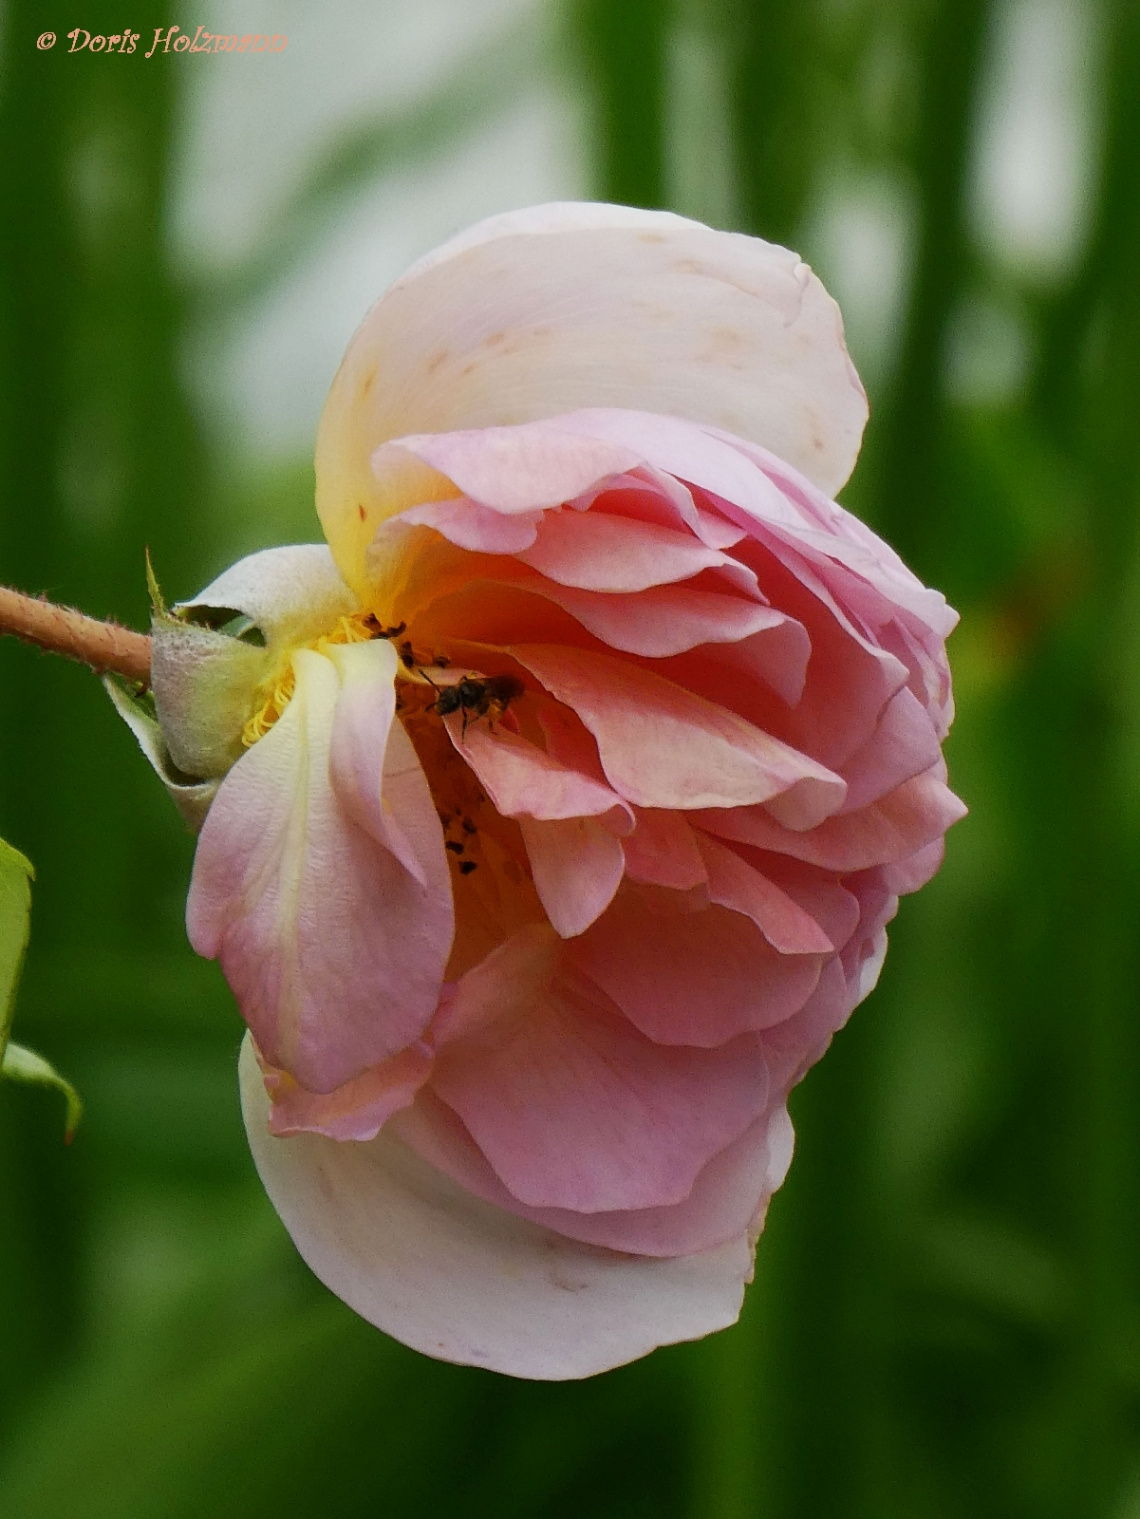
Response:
[[140, 205, 964, 1378]]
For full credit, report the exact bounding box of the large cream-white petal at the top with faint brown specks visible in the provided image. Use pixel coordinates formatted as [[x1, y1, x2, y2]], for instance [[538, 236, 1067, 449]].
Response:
[[316, 205, 866, 592]]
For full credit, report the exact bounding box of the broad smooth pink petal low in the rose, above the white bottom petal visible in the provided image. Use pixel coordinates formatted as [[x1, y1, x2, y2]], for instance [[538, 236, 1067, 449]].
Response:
[[432, 928, 768, 1212]]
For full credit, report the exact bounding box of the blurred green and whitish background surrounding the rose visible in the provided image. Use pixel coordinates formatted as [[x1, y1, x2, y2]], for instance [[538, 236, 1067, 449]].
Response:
[[0, 0, 1140, 1519]]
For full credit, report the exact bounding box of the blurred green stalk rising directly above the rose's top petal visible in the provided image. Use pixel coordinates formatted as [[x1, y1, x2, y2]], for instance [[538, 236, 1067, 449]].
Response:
[[575, 0, 673, 208]]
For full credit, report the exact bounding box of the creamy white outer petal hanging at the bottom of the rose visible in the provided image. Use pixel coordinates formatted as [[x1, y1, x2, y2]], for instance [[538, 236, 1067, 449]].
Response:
[[240, 1039, 752, 1381]]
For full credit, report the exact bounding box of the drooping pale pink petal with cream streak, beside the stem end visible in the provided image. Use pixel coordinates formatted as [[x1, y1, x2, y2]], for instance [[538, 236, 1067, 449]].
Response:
[[187, 641, 453, 1092]]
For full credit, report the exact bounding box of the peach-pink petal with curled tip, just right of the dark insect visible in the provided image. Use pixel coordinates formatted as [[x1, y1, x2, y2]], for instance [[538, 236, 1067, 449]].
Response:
[[508, 644, 847, 828]]
